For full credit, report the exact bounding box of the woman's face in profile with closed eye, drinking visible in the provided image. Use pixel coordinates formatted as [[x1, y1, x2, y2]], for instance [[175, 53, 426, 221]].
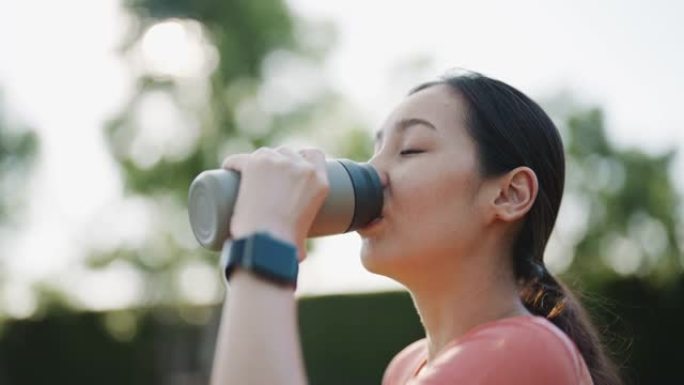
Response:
[[359, 85, 484, 282]]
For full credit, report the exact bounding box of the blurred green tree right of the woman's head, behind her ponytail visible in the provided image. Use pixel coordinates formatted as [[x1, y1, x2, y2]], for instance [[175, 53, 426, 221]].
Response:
[[547, 95, 684, 286]]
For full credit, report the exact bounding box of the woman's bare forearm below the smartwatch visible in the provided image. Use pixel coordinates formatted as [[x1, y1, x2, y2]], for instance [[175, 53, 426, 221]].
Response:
[[211, 270, 306, 385]]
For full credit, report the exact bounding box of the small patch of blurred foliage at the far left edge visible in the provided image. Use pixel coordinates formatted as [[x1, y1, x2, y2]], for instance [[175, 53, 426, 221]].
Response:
[[0, 93, 38, 223]]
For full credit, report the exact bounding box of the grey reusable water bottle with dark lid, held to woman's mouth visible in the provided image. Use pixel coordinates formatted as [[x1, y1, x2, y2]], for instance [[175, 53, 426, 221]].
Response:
[[188, 159, 383, 251]]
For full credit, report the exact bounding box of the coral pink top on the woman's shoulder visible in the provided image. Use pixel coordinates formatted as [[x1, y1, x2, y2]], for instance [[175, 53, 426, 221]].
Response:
[[382, 315, 593, 385]]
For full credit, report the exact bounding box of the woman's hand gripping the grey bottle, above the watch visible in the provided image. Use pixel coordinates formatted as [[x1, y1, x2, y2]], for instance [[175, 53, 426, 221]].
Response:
[[222, 147, 330, 261]]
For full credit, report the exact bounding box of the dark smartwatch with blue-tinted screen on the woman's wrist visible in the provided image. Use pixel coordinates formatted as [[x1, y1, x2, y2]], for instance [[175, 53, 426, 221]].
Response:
[[224, 232, 299, 288]]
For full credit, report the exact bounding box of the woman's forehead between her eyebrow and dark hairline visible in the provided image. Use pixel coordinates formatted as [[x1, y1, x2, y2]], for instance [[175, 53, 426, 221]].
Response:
[[376, 84, 465, 139]]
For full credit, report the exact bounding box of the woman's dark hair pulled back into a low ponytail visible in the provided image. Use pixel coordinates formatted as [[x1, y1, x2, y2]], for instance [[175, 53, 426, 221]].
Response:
[[411, 72, 622, 385]]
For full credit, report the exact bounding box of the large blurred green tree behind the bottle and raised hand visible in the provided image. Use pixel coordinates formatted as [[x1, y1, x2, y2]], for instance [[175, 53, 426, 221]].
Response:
[[89, 0, 366, 304]]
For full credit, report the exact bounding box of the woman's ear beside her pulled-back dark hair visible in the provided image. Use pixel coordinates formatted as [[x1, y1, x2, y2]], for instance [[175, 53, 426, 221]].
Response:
[[493, 167, 539, 222]]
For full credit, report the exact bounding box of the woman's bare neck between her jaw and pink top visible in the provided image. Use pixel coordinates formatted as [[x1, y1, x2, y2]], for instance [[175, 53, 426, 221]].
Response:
[[407, 243, 530, 362]]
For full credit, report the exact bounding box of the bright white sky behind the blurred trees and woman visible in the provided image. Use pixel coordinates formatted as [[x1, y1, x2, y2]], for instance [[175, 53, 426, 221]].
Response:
[[0, 0, 684, 316]]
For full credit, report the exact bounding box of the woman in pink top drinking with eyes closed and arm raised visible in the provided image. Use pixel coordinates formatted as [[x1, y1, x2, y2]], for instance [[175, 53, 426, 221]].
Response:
[[212, 73, 620, 385]]
